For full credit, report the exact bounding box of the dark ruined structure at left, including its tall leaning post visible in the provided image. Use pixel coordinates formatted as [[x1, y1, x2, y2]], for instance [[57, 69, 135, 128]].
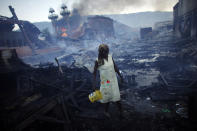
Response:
[[0, 6, 63, 57]]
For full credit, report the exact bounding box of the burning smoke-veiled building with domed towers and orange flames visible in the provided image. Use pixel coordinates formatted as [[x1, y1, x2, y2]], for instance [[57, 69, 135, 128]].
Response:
[[48, 4, 114, 40]]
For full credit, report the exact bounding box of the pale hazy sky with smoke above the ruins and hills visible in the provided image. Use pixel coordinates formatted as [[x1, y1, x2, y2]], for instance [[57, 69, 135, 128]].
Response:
[[0, 0, 178, 22]]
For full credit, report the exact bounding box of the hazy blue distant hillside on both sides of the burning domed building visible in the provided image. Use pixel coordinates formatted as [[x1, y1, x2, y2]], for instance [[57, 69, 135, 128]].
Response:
[[33, 12, 173, 35]]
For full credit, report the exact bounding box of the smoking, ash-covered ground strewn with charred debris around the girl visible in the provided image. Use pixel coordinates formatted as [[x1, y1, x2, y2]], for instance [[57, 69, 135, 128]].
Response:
[[1, 29, 197, 131]]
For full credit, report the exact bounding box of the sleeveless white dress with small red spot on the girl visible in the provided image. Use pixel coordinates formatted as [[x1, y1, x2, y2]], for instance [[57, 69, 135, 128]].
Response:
[[97, 55, 120, 103]]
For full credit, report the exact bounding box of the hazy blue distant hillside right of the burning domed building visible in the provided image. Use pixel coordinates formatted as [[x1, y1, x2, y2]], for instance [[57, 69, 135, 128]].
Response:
[[104, 12, 173, 28]]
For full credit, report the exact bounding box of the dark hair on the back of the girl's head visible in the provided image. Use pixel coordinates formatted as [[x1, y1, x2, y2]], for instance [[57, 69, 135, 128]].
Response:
[[98, 44, 109, 66]]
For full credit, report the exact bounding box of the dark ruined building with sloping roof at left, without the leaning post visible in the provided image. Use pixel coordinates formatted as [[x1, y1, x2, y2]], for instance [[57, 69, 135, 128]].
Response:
[[0, 16, 40, 56]]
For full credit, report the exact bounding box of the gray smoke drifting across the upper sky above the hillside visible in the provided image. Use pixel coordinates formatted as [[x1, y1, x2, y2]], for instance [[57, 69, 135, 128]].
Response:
[[73, 0, 178, 15]]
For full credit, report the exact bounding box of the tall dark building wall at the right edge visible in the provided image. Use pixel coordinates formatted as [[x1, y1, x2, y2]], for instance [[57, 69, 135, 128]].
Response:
[[173, 0, 197, 39]]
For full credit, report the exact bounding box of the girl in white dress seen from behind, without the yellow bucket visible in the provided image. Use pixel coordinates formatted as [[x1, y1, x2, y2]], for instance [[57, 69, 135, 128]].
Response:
[[93, 44, 123, 117]]
